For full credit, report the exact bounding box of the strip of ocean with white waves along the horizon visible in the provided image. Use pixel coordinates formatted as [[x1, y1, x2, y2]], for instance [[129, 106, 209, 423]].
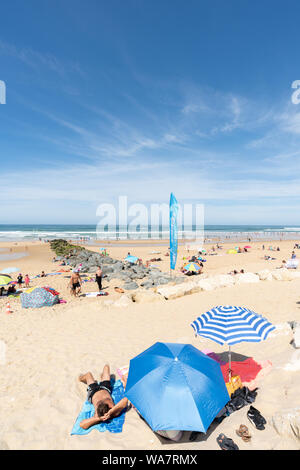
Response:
[[0, 224, 300, 243]]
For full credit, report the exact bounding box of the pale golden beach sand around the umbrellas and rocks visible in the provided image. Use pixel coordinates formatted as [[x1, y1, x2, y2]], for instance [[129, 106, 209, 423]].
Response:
[[0, 241, 300, 450]]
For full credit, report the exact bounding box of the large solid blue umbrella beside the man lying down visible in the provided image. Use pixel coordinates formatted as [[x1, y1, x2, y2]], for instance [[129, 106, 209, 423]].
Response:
[[125, 342, 230, 432]]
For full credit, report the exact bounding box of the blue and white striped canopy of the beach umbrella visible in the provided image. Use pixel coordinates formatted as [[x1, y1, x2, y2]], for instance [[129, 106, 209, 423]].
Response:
[[191, 306, 275, 345]]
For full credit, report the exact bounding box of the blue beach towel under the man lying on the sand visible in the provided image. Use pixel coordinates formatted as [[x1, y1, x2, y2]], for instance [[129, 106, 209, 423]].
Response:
[[71, 380, 125, 436]]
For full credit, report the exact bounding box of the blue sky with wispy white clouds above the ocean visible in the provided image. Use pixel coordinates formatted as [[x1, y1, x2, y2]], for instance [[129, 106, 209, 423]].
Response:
[[0, 0, 300, 225]]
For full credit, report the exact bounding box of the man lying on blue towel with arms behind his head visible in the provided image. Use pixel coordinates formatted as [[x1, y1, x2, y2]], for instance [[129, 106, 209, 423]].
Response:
[[79, 364, 128, 429]]
